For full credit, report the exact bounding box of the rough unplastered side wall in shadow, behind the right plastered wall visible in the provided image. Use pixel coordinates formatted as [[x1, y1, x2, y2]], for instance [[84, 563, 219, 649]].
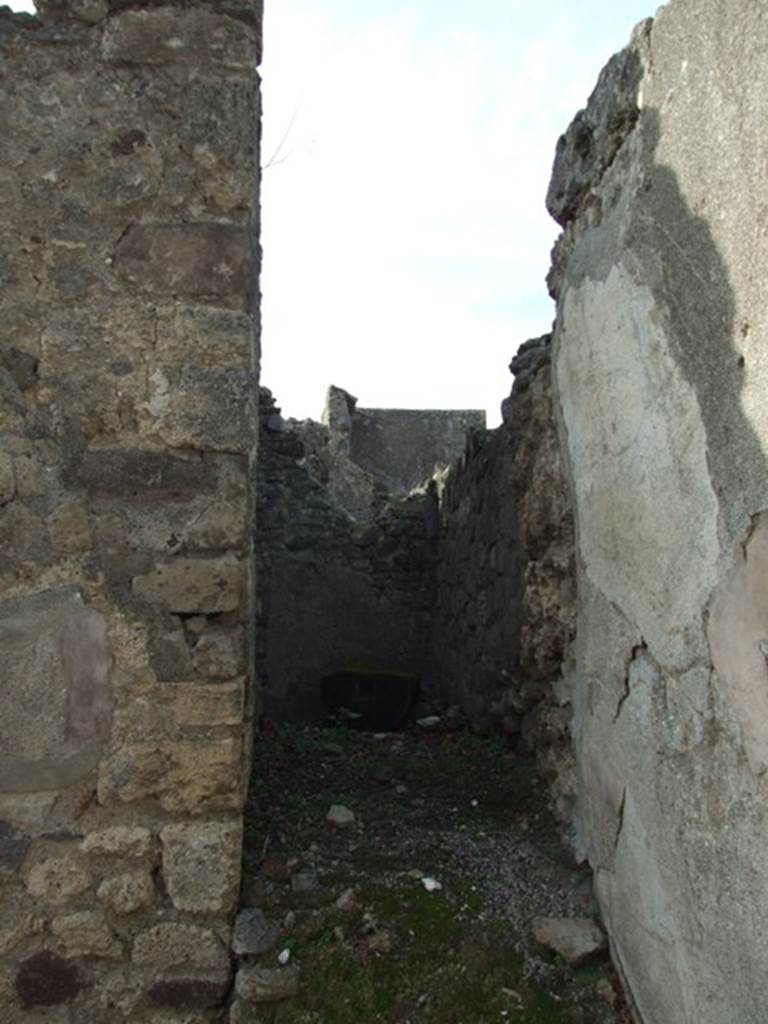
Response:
[[433, 335, 575, 820]]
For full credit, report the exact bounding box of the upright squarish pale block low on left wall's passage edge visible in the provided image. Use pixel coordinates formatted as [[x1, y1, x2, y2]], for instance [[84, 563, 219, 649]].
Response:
[[160, 821, 243, 913]]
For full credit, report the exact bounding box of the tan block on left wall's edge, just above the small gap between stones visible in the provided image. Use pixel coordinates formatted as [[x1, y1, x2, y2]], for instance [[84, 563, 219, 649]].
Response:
[[133, 557, 244, 615]]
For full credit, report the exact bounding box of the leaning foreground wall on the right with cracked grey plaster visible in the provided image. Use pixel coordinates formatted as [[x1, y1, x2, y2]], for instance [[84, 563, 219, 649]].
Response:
[[550, 0, 768, 1024]]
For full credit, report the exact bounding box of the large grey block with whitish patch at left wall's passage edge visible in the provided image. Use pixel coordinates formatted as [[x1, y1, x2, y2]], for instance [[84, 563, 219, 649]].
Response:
[[142, 365, 255, 455]]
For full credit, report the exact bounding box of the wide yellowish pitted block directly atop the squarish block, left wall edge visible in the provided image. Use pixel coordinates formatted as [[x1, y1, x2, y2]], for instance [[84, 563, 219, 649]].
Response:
[[98, 736, 243, 814]]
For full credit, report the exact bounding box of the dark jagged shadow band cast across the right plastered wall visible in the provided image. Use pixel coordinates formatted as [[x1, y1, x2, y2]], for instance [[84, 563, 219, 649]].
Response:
[[628, 108, 768, 543]]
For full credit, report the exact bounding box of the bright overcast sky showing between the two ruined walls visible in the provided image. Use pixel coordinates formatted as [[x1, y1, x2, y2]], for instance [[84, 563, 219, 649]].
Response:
[[7, 0, 656, 424]]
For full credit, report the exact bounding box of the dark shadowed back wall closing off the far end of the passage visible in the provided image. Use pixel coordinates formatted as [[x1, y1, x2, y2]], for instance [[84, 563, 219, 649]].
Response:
[[256, 389, 437, 721]]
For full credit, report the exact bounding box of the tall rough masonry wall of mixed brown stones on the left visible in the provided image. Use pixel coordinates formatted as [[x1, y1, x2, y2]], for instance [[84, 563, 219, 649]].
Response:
[[0, 0, 260, 1024]]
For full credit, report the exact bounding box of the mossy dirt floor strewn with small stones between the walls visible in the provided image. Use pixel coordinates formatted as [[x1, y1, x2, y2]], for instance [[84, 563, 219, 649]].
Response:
[[243, 722, 630, 1024]]
